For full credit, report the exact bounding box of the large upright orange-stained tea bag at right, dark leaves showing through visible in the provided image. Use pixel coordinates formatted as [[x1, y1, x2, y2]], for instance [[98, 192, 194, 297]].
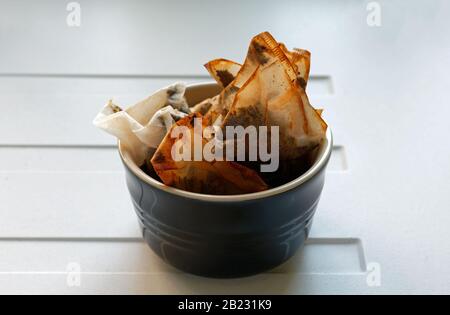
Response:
[[223, 44, 327, 160]]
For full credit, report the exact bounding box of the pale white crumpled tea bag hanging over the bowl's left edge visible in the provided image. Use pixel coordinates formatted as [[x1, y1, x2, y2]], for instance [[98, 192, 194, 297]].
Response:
[[93, 83, 190, 165]]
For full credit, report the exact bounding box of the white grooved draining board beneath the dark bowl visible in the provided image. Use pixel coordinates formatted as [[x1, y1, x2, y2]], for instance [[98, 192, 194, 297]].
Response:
[[0, 0, 450, 294]]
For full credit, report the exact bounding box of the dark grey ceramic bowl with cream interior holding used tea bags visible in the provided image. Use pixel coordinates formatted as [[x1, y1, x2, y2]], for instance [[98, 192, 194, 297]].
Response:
[[119, 83, 332, 278]]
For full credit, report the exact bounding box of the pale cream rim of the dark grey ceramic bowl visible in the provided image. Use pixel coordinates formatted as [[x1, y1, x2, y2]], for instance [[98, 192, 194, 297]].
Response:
[[117, 82, 333, 202]]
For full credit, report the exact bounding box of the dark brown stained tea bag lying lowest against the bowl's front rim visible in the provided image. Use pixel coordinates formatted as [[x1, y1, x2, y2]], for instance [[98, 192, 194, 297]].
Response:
[[151, 113, 268, 195]]
